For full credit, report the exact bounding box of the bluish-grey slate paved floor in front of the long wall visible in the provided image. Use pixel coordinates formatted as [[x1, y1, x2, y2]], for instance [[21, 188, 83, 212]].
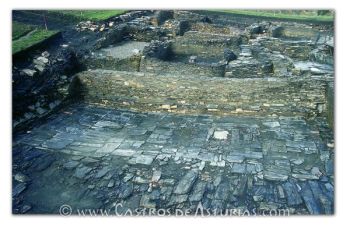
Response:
[[13, 104, 334, 214]]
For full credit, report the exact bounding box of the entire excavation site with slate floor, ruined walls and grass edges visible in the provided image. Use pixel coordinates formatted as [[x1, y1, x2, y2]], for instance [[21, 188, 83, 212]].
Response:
[[12, 10, 335, 216]]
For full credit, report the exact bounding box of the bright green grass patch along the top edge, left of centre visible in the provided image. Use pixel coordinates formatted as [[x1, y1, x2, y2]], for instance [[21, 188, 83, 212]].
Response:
[[49, 10, 127, 21]]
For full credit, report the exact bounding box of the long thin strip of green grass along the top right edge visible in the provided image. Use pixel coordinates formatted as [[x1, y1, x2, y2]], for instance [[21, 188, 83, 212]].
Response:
[[211, 10, 334, 22]]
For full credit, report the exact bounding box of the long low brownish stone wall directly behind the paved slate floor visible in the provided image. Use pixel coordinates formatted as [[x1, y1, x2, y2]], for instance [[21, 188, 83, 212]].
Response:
[[76, 70, 326, 116]]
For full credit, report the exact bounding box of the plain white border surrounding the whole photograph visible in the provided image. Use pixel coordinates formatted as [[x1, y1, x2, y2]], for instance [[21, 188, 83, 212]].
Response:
[[0, 0, 350, 230]]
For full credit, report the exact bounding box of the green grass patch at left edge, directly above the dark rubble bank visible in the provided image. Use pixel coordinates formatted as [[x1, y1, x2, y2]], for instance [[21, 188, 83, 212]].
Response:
[[12, 29, 58, 54]]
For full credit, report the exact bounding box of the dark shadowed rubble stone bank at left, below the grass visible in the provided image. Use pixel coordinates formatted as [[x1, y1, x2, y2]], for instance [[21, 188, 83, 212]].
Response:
[[12, 50, 80, 130]]
